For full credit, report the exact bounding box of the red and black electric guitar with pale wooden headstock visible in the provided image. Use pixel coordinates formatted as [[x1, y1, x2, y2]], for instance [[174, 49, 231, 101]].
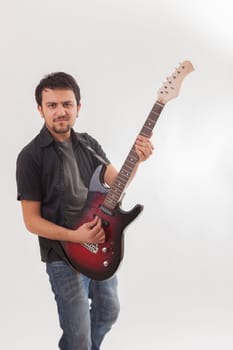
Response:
[[60, 61, 194, 280]]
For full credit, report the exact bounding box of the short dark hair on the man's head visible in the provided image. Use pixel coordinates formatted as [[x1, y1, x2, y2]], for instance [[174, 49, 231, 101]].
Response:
[[35, 72, 80, 106]]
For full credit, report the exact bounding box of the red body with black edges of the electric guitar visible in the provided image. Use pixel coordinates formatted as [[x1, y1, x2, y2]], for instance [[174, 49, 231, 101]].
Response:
[[60, 166, 143, 280]]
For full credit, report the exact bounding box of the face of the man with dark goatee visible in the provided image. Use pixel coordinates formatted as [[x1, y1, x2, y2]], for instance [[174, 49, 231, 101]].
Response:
[[38, 89, 80, 141]]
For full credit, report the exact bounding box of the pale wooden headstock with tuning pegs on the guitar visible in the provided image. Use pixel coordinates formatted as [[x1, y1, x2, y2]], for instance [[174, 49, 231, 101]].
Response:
[[158, 61, 194, 104]]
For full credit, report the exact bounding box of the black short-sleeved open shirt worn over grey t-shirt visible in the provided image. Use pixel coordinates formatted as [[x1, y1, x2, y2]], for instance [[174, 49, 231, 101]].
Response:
[[16, 126, 109, 262]]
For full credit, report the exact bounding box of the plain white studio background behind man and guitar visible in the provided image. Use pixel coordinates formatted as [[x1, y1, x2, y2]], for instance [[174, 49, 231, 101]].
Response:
[[0, 0, 233, 350]]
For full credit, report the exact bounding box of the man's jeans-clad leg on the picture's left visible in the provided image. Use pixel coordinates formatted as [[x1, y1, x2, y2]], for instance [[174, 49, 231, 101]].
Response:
[[47, 261, 91, 350]]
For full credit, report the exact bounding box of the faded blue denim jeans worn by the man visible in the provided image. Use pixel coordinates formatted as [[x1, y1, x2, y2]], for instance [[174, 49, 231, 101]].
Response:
[[47, 261, 120, 350]]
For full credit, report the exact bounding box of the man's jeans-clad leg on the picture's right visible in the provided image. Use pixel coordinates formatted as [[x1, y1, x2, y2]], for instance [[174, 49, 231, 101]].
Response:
[[89, 276, 120, 350]]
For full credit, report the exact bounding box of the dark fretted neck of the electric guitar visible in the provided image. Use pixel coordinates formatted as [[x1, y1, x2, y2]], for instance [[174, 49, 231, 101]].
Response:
[[103, 101, 164, 210]]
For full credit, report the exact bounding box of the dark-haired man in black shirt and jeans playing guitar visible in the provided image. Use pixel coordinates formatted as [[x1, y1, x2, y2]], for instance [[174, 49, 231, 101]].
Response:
[[16, 72, 153, 350]]
